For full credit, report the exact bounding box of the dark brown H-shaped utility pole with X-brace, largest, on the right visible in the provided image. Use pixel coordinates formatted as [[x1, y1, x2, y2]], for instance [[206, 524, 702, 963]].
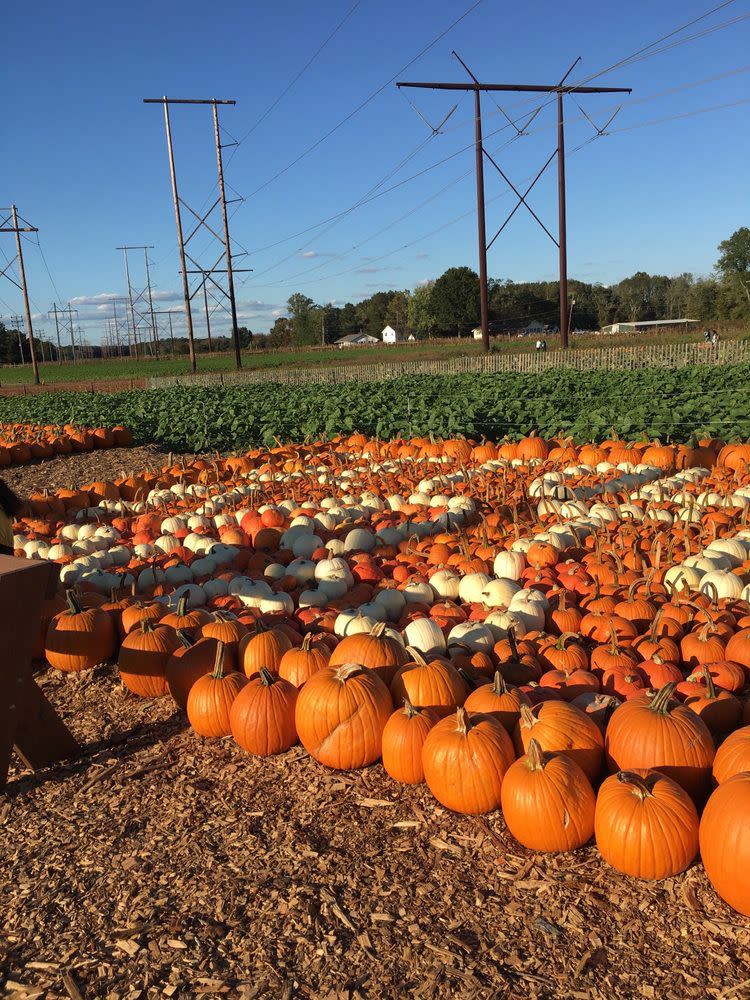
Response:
[[396, 59, 632, 354]]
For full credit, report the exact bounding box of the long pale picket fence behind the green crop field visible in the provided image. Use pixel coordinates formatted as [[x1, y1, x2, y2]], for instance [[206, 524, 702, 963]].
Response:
[[148, 340, 750, 389]]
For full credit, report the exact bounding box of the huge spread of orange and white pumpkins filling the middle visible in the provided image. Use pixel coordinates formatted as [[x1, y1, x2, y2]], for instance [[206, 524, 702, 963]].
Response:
[[16, 435, 750, 915]]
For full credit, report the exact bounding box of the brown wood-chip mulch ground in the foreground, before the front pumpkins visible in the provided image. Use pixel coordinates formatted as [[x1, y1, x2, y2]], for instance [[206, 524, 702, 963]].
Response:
[[0, 667, 750, 1000]]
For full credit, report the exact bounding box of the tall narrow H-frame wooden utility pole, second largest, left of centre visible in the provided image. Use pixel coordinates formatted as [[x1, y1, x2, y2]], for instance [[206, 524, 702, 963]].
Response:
[[143, 97, 250, 371]]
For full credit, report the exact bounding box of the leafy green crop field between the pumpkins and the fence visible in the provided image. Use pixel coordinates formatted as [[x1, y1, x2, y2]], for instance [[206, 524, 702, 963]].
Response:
[[0, 364, 750, 451]]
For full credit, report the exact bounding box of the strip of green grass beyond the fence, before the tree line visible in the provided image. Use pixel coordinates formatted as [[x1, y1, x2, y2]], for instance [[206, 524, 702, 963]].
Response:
[[0, 330, 750, 387]]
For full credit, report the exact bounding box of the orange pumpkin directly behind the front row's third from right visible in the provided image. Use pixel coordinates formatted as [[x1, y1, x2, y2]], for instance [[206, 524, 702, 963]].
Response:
[[513, 701, 604, 784]]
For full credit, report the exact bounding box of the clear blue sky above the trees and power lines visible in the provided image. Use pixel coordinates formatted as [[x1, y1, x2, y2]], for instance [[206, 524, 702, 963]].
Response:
[[0, 0, 750, 342]]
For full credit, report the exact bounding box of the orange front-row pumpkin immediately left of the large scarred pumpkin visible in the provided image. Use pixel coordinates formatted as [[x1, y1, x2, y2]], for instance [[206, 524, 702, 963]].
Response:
[[229, 667, 298, 757]]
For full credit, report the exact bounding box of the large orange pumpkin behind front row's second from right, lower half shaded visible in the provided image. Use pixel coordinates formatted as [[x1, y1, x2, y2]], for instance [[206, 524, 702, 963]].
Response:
[[605, 683, 714, 801]]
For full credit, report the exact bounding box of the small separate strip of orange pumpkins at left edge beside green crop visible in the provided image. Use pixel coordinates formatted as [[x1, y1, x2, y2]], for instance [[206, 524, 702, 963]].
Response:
[[0, 423, 133, 466]]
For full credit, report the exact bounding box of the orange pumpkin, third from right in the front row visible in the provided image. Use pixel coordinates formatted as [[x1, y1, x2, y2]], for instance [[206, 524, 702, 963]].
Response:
[[501, 739, 596, 853]]
